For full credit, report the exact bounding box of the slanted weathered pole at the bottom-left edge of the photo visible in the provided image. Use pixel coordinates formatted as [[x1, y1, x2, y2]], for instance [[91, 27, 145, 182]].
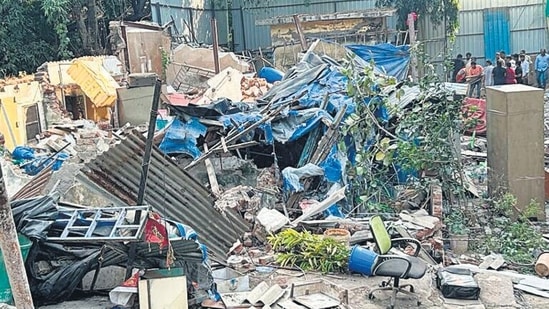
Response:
[[0, 167, 34, 309]]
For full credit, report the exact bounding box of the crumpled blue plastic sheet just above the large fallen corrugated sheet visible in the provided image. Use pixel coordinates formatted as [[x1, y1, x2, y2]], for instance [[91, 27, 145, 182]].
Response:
[[160, 118, 208, 159]]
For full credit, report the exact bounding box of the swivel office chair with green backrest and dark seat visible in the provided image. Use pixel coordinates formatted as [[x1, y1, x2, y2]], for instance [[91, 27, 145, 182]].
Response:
[[368, 216, 427, 309]]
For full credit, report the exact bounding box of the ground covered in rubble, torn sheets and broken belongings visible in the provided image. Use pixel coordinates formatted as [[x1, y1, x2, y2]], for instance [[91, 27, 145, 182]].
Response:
[[1, 15, 549, 308]]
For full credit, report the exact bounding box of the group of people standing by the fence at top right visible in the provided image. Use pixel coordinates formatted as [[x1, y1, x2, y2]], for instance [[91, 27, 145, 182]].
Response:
[[452, 49, 549, 98]]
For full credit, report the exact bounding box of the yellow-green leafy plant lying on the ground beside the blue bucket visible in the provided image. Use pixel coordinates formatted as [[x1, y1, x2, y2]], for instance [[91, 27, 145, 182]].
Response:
[[268, 229, 349, 273]]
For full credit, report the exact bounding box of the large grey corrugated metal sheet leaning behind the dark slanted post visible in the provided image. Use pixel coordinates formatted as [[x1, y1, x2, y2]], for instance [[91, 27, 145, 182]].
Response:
[[82, 131, 249, 257]]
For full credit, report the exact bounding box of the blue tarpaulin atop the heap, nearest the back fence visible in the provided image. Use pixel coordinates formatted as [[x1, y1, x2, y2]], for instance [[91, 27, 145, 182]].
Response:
[[345, 43, 410, 81]]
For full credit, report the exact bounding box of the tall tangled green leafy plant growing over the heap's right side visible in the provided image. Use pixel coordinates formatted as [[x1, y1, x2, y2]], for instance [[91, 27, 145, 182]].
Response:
[[339, 46, 466, 209]]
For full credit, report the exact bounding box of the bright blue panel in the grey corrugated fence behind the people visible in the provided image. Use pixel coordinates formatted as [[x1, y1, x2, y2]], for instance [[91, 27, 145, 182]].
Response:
[[484, 9, 511, 58]]
